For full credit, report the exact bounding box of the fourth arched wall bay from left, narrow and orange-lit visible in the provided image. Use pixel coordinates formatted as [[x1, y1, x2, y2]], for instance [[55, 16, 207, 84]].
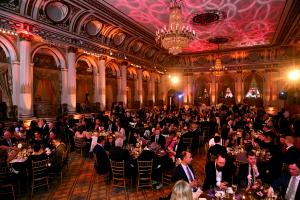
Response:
[[105, 62, 118, 110]]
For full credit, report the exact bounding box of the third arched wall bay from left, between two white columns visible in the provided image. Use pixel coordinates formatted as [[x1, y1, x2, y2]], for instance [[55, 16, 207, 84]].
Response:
[[76, 59, 94, 113]]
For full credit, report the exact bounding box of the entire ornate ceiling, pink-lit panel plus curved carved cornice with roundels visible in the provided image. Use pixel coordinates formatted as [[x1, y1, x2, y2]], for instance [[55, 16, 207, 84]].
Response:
[[0, 0, 300, 71]]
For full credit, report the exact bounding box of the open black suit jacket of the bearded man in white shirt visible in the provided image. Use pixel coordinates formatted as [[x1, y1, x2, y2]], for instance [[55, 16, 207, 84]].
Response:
[[203, 161, 232, 191]]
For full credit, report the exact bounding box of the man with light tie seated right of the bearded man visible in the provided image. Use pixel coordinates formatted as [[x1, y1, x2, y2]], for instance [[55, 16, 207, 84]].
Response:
[[237, 151, 263, 188]]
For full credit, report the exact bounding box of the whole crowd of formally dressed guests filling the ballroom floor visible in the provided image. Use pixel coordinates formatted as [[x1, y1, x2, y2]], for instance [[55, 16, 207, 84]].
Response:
[[0, 104, 300, 199]]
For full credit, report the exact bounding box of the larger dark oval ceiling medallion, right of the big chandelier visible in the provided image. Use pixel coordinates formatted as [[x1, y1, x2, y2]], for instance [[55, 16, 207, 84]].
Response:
[[191, 10, 226, 25]]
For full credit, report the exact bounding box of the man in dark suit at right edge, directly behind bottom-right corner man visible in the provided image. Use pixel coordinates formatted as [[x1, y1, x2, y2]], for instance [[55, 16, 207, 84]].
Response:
[[283, 136, 300, 164]]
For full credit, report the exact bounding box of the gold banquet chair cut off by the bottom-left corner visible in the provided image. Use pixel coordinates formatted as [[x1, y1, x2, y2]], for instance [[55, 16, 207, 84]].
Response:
[[0, 167, 15, 200]]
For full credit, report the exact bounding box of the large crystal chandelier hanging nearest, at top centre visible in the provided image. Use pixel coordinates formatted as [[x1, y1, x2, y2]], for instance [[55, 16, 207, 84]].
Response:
[[156, 0, 196, 55]]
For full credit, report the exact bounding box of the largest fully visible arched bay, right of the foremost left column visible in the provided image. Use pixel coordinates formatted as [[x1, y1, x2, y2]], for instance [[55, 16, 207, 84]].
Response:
[[32, 47, 62, 117]]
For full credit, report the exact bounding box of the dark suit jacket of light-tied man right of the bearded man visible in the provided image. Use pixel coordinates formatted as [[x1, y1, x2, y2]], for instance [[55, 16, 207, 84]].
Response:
[[237, 163, 264, 187]]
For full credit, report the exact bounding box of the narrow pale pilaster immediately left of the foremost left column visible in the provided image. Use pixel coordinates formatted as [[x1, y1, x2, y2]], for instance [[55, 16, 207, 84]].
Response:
[[11, 61, 20, 107]]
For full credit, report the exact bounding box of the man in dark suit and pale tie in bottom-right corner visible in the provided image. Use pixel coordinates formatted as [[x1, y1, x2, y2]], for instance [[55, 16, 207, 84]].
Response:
[[268, 160, 300, 200]]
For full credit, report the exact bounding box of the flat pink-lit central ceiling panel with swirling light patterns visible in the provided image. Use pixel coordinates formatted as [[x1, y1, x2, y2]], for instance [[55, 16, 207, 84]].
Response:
[[106, 0, 286, 53]]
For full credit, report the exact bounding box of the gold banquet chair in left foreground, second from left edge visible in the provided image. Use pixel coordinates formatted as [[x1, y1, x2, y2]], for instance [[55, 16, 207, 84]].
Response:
[[31, 159, 49, 199]]
